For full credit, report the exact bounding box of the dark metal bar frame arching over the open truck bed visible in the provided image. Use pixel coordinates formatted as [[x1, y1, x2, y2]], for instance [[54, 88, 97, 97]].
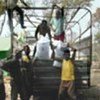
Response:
[[22, 7, 92, 63]]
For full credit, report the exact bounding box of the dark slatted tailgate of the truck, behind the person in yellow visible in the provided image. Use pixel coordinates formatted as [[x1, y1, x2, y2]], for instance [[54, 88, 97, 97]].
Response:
[[33, 60, 90, 93]]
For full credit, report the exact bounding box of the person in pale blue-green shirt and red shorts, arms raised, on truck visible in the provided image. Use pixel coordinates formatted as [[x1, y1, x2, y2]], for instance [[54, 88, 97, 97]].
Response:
[[50, 5, 65, 41]]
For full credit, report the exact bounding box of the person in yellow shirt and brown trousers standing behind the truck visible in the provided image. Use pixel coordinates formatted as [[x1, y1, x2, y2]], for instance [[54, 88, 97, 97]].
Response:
[[58, 45, 76, 100]]
